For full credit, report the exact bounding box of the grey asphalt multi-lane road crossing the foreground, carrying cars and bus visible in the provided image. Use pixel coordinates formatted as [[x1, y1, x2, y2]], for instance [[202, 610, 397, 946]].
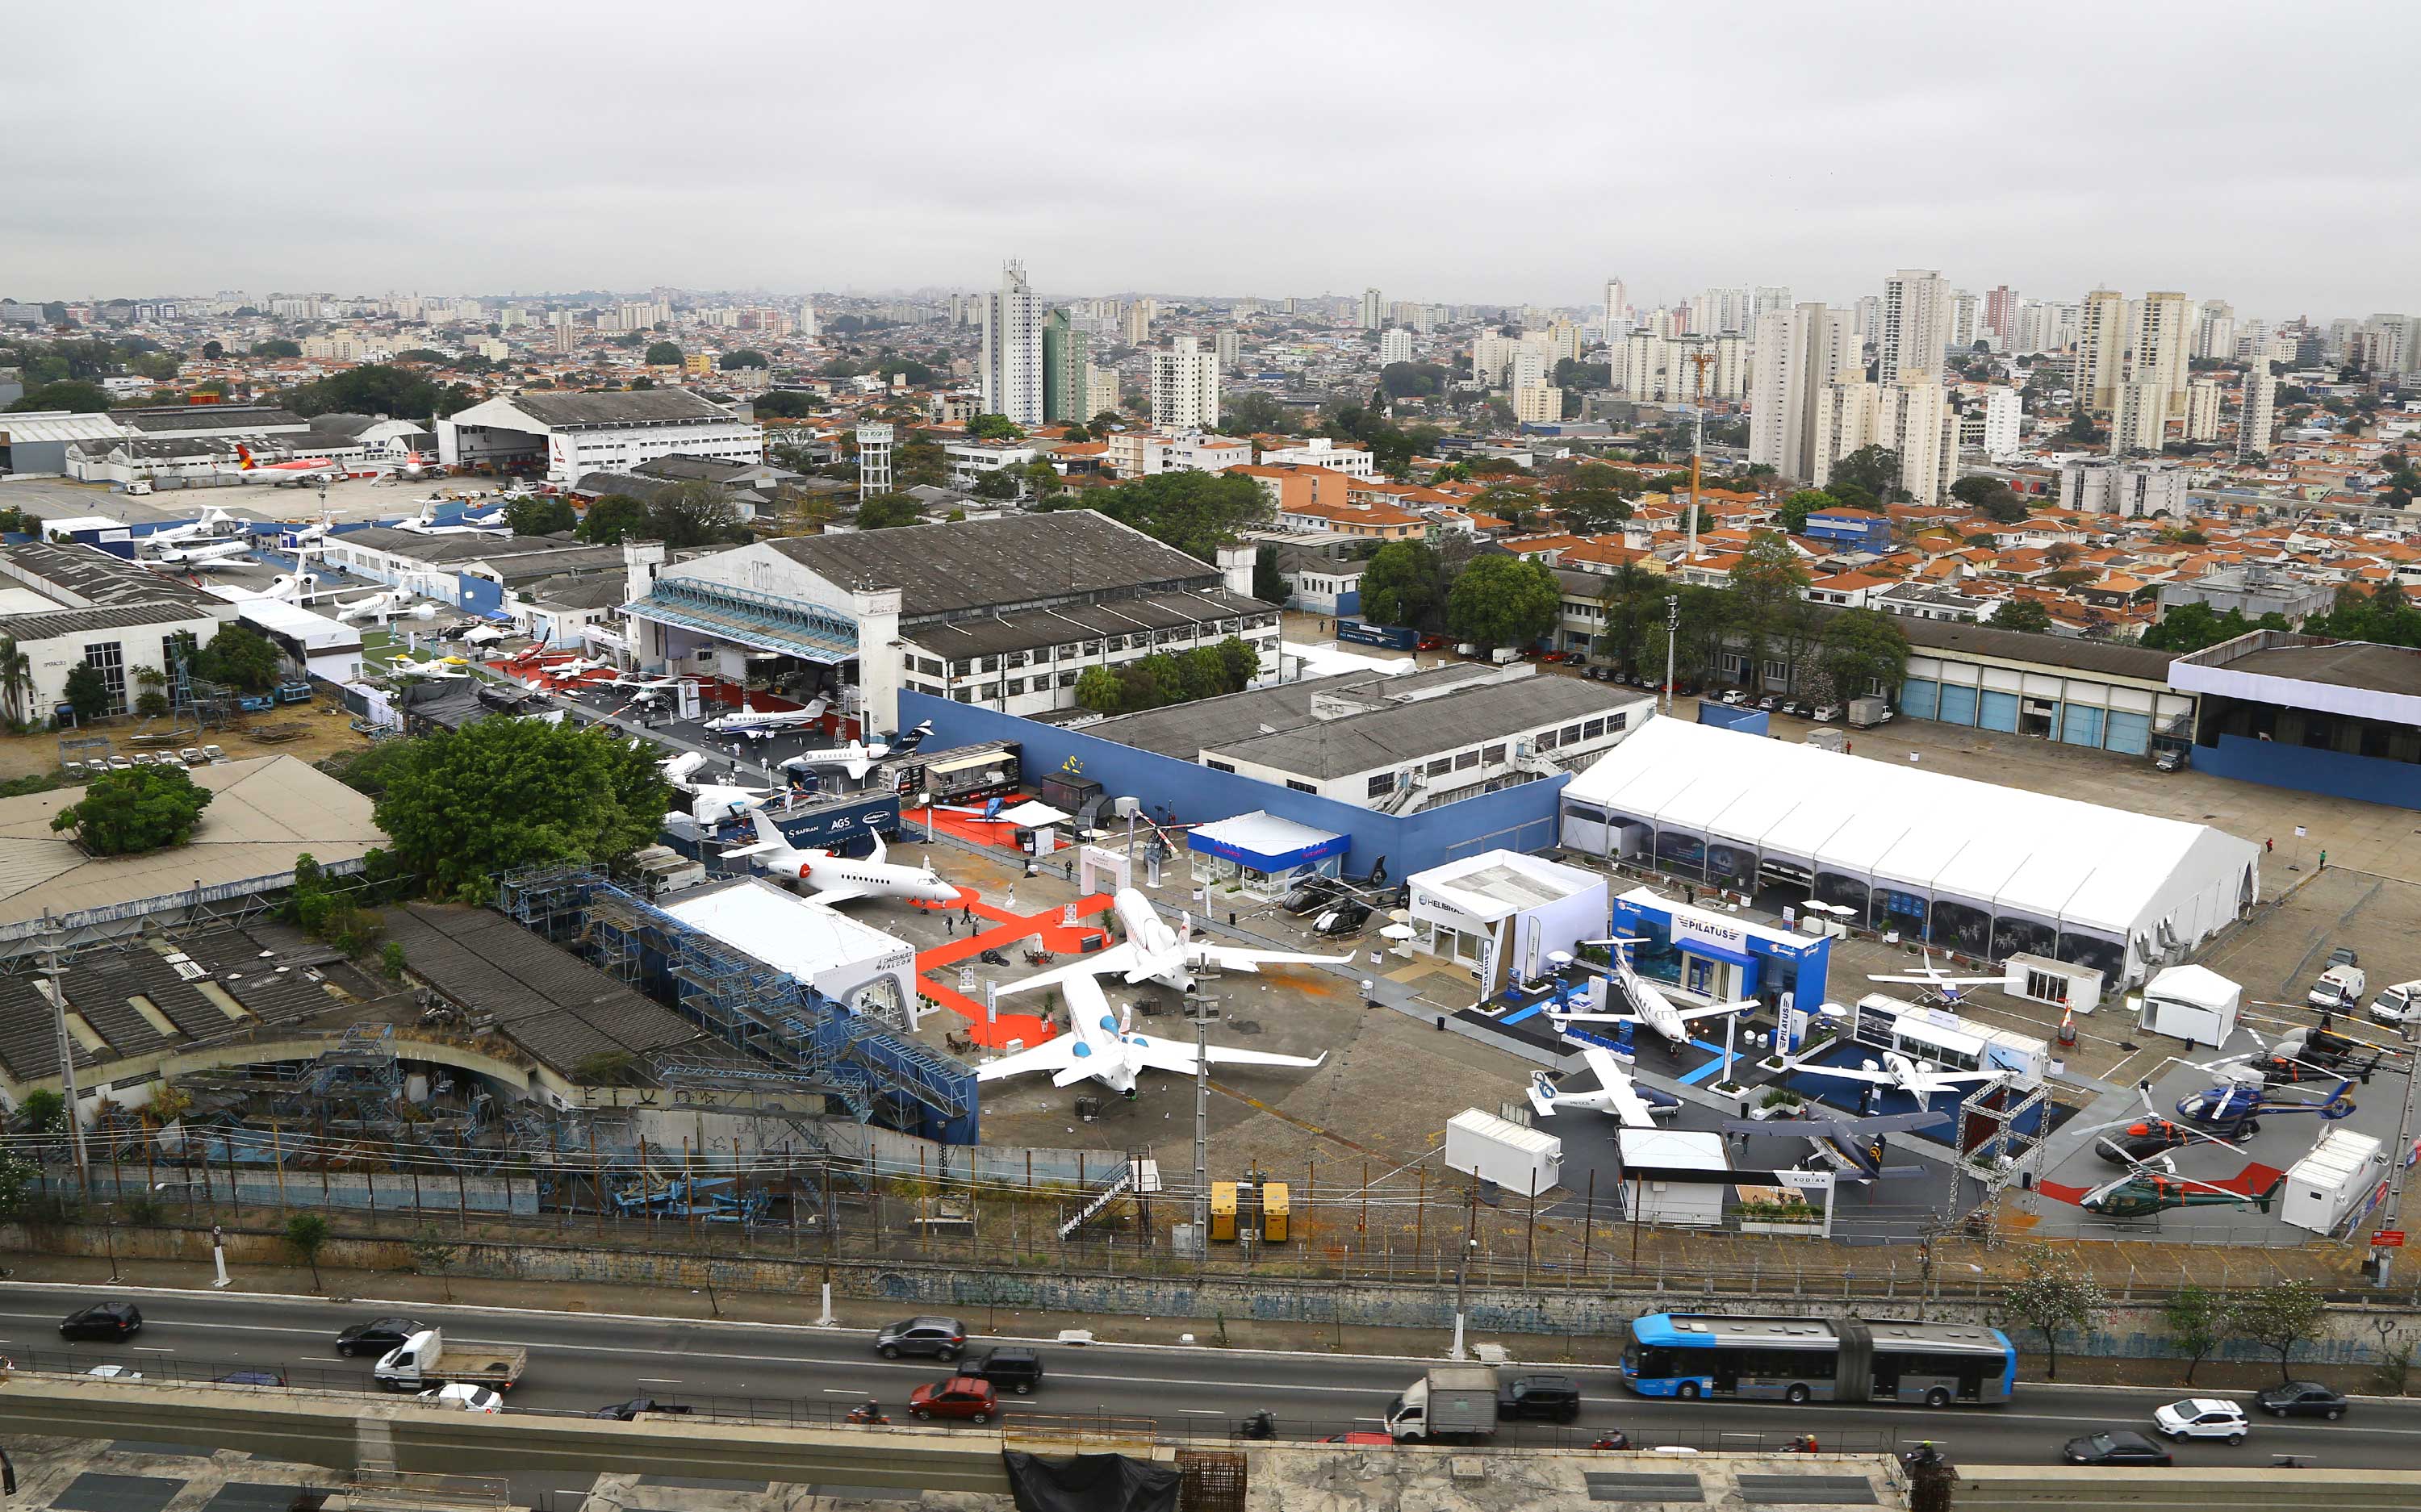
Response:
[[0, 1284, 2421, 1468]]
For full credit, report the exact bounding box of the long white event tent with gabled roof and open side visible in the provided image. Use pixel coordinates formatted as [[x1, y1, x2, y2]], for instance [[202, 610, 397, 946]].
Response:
[[1562, 719, 2261, 989]]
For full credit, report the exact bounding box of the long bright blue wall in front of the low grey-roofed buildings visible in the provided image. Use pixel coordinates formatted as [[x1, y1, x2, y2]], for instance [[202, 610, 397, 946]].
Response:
[[901, 692, 1571, 880]]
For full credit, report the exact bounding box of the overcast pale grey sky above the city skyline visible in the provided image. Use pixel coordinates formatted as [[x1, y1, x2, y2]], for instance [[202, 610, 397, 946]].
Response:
[[0, 0, 2421, 317]]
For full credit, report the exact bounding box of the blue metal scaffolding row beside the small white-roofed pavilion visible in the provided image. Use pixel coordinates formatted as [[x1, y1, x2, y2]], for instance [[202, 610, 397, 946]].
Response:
[[496, 866, 978, 1144]]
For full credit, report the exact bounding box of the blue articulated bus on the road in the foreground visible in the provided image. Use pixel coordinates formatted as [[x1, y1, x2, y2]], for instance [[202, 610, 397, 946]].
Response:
[[1622, 1314, 2017, 1408]]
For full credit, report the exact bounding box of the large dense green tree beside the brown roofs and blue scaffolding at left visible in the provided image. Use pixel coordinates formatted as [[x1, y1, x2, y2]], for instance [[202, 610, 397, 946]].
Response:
[[375, 719, 668, 902]]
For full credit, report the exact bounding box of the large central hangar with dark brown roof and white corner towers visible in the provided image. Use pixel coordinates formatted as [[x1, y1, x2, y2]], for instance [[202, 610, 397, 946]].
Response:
[[622, 511, 1278, 731]]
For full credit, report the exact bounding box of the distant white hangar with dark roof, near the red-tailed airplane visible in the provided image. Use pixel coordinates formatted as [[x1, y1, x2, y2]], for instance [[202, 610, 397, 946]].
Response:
[[438, 390, 765, 489]]
